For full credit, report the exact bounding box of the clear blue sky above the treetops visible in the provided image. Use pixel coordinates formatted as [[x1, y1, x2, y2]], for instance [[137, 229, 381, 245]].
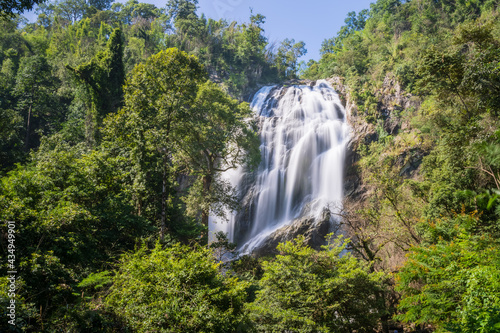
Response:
[[26, 0, 375, 61]]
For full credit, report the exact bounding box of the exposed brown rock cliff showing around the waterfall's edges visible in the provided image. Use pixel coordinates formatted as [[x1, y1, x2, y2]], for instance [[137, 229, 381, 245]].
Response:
[[236, 73, 424, 256]]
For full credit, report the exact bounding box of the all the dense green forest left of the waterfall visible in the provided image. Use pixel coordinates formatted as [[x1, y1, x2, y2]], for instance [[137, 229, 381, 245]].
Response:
[[0, 0, 312, 332]]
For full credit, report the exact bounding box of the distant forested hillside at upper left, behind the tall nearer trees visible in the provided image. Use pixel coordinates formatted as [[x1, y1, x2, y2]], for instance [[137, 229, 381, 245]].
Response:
[[0, 0, 306, 169]]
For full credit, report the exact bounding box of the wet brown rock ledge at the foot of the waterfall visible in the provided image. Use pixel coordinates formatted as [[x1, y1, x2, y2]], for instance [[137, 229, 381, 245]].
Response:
[[252, 209, 334, 257]]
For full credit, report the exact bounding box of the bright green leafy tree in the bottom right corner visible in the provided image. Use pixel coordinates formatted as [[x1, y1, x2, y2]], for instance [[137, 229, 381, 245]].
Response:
[[397, 213, 500, 333]]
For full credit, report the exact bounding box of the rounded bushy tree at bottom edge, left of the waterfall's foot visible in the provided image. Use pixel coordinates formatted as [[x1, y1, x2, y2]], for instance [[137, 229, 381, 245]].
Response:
[[106, 244, 252, 333]]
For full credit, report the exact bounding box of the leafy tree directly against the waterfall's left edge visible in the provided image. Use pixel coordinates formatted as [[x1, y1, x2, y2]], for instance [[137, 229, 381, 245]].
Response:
[[174, 81, 260, 232]]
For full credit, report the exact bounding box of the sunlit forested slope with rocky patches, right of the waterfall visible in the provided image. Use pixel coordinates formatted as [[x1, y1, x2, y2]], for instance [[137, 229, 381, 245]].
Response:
[[304, 0, 500, 332]]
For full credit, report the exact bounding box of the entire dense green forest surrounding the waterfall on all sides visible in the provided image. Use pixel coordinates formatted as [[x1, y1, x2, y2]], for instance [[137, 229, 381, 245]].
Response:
[[0, 0, 500, 333]]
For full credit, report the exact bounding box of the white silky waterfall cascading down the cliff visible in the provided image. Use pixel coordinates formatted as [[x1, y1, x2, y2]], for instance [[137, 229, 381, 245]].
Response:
[[211, 80, 349, 253]]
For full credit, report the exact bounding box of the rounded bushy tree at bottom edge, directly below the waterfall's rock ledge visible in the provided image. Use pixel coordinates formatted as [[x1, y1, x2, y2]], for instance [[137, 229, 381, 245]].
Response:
[[249, 236, 384, 332]]
